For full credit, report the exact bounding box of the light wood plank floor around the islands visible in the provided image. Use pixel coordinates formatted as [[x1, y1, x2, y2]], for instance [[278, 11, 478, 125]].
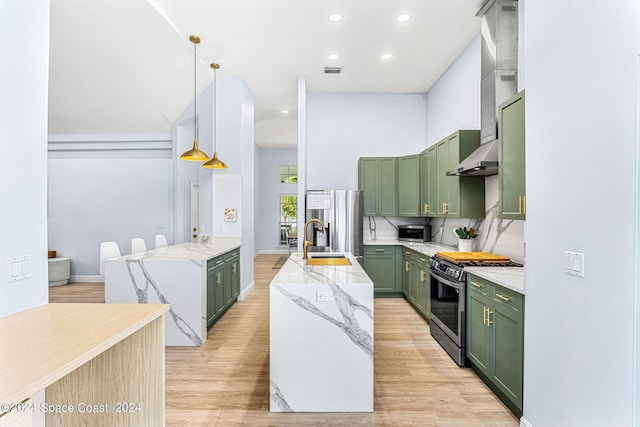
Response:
[[50, 255, 519, 427]]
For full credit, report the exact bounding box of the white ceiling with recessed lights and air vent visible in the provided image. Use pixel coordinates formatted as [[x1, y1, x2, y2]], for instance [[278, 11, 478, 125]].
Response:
[[49, 0, 483, 147]]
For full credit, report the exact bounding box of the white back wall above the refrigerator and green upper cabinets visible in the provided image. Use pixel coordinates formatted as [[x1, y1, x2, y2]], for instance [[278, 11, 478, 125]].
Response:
[[303, 92, 426, 190]]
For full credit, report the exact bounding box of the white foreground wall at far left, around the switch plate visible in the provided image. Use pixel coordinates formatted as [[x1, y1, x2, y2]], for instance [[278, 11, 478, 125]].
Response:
[[0, 0, 49, 317]]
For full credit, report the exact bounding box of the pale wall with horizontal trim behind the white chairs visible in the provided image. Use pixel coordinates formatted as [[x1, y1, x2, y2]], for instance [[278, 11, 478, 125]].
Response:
[[48, 135, 174, 281]]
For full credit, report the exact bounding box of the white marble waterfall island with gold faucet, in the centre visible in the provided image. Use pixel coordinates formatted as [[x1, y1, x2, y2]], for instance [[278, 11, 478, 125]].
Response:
[[270, 253, 373, 412]]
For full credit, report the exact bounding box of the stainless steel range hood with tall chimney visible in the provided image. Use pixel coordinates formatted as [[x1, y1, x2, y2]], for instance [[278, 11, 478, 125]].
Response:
[[447, 0, 518, 176]]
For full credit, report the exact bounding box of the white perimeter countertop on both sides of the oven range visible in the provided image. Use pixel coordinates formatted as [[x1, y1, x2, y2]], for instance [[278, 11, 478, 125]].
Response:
[[364, 239, 525, 295]]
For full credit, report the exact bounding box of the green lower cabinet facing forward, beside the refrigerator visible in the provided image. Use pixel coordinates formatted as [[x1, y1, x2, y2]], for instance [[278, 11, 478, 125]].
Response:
[[364, 245, 402, 296]]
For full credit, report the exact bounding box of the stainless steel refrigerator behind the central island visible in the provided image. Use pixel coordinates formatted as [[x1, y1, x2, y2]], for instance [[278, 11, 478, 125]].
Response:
[[298, 190, 364, 264]]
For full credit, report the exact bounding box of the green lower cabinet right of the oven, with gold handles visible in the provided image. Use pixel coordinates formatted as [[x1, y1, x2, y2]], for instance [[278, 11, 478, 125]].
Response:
[[467, 274, 524, 417]]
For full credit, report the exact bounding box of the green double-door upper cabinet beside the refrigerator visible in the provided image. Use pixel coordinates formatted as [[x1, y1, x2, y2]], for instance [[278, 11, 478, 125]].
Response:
[[358, 157, 397, 216]]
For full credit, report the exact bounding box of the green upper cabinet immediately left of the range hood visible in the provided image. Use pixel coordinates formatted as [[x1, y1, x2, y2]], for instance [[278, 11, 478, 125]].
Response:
[[428, 130, 485, 218]]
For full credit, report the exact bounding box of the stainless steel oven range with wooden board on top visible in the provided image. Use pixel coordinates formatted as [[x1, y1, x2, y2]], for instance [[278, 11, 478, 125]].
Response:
[[429, 254, 522, 366]]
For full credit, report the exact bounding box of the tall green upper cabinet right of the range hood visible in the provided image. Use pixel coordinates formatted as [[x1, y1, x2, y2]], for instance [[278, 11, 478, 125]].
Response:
[[498, 91, 527, 219]]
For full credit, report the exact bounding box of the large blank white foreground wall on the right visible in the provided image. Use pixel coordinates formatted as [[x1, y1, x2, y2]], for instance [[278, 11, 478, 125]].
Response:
[[524, 0, 640, 427]]
